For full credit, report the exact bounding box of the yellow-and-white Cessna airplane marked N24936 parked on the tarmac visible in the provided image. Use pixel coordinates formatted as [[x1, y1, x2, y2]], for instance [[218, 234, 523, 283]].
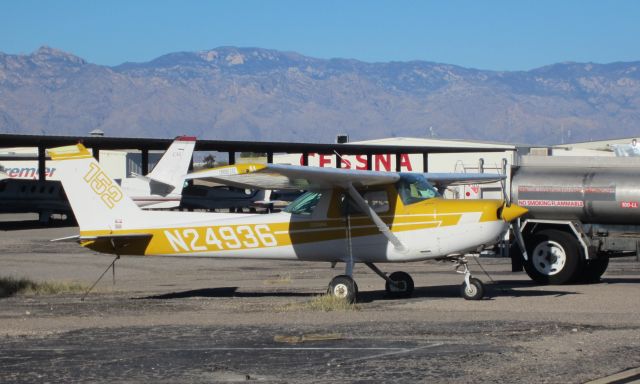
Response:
[[49, 144, 526, 301]]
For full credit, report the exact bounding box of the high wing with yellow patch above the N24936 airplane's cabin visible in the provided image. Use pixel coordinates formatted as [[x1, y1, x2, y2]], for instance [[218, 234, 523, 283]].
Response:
[[186, 164, 400, 191]]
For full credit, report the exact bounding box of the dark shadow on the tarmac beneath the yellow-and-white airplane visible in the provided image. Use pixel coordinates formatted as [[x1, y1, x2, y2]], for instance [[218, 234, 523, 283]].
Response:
[[132, 281, 578, 303]]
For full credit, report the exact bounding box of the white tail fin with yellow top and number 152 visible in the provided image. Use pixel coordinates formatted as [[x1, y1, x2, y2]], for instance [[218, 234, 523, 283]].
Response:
[[48, 144, 141, 231]]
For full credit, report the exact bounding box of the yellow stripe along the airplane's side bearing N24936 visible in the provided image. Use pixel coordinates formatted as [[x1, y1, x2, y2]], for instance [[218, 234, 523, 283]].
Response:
[[80, 200, 499, 255]]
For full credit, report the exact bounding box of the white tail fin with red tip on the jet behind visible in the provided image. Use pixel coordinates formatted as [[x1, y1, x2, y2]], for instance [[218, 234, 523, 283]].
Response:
[[147, 136, 196, 195]]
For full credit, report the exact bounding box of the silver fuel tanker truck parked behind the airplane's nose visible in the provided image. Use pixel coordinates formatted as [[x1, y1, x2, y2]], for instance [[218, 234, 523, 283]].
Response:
[[507, 156, 640, 284]]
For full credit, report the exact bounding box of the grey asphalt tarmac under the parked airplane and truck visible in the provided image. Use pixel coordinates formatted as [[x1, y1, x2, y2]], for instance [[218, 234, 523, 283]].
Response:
[[0, 214, 640, 383]]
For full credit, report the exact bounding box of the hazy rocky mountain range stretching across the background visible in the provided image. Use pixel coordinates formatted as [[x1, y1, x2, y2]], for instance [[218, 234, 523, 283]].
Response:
[[0, 47, 640, 144]]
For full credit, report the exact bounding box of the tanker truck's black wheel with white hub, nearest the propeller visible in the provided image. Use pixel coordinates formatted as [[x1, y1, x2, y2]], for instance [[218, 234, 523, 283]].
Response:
[[524, 229, 582, 284]]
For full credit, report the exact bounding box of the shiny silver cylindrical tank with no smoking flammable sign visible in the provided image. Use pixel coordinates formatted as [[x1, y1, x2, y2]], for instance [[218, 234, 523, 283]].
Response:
[[511, 158, 640, 224]]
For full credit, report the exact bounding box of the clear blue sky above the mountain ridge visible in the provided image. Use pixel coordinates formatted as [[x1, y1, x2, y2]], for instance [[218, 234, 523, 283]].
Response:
[[0, 0, 640, 70]]
